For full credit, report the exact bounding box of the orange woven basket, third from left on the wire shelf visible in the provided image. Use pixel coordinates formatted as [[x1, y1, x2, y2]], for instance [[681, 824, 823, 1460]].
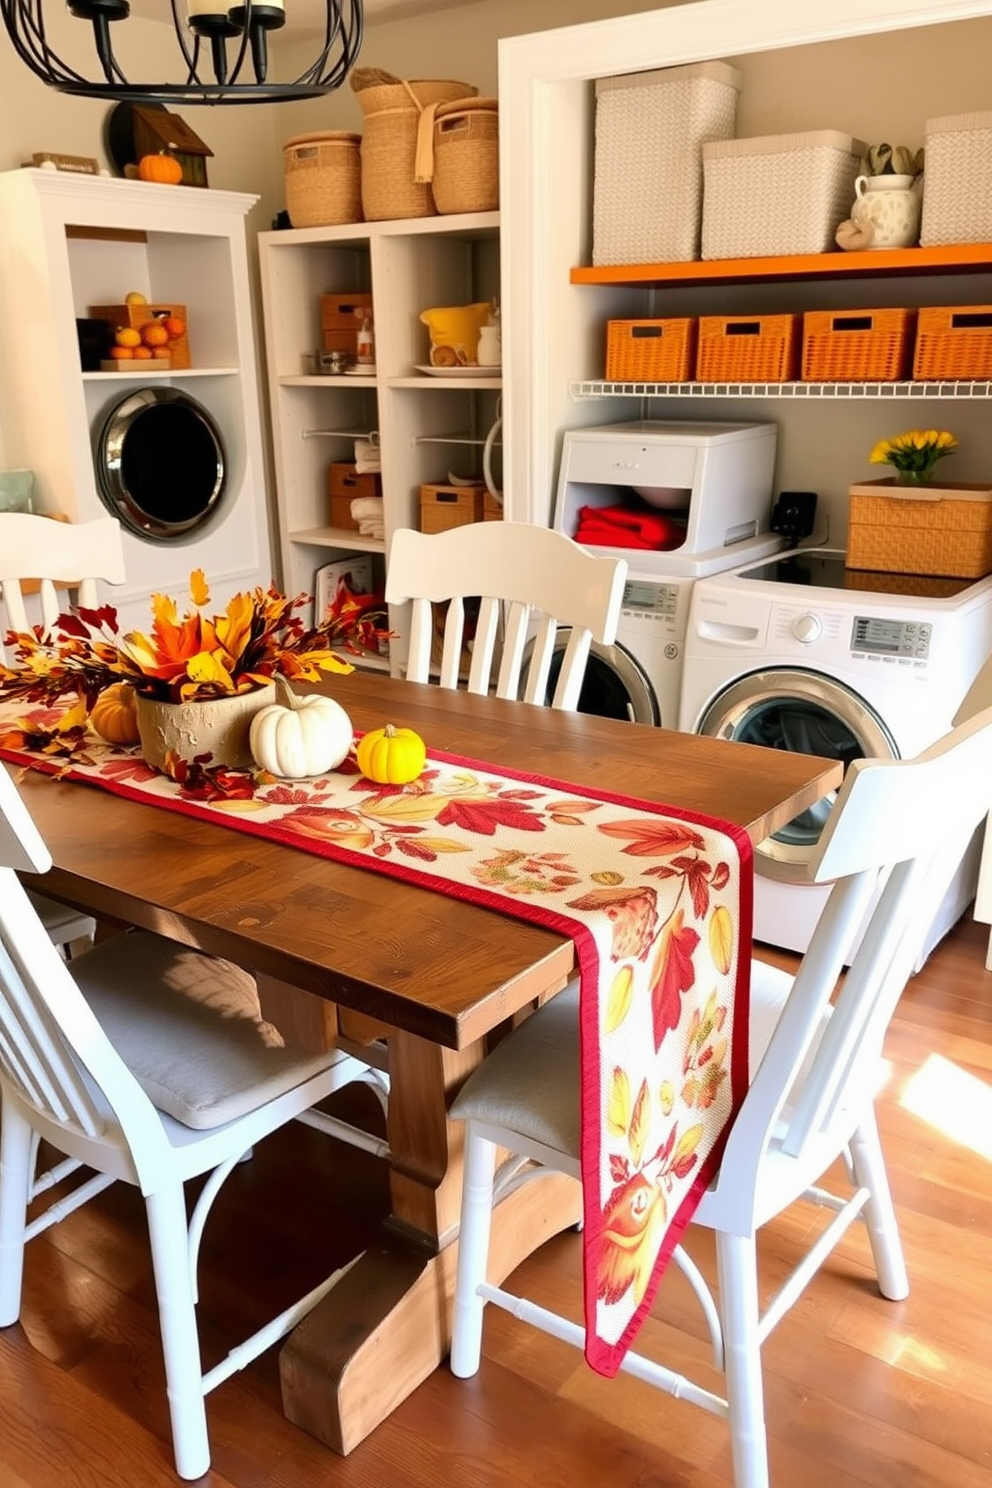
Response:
[[803, 310, 916, 382]]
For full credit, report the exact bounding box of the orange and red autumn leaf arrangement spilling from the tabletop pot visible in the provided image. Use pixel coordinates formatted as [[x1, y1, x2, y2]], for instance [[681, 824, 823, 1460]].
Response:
[[0, 568, 390, 773]]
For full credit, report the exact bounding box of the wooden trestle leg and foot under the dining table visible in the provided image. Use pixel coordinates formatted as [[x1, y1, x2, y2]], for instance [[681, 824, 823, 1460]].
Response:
[[280, 1033, 580, 1454]]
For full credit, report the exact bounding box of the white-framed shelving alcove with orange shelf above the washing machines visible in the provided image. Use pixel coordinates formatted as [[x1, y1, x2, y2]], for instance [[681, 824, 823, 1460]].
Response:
[[500, 0, 992, 539]]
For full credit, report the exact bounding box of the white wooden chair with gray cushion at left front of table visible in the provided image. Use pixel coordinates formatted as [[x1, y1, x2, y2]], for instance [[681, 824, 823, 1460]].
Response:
[[0, 766, 380, 1478]]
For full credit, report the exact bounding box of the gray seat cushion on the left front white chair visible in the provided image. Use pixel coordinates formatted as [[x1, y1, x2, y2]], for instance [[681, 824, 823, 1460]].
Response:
[[73, 931, 337, 1131]]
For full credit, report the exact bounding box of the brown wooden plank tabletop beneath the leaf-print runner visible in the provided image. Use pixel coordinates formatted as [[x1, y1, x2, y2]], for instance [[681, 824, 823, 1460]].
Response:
[[18, 671, 842, 1049]]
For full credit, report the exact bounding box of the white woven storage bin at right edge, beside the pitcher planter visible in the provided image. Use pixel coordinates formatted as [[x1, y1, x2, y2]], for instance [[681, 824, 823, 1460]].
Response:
[[919, 113, 992, 248]]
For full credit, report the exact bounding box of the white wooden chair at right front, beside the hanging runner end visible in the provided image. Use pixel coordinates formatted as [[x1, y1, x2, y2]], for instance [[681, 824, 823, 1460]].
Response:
[[451, 710, 992, 1488]]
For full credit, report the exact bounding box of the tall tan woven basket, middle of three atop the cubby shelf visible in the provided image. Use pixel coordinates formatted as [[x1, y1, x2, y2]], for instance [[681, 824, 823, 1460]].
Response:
[[350, 67, 479, 222]]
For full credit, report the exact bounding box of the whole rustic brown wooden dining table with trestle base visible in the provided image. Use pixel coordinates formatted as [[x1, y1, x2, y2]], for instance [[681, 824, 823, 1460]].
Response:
[[11, 671, 842, 1452]]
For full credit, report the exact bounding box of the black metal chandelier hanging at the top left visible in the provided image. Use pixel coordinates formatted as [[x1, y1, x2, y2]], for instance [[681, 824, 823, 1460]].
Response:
[[0, 0, 364, 104]]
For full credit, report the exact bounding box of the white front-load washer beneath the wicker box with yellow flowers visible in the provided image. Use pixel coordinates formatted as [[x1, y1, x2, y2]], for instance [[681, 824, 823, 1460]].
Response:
[[680, 548, 992, 954]]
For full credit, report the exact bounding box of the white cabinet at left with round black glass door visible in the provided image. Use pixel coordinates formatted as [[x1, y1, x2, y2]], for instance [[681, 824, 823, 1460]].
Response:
[[0, 170, 272, 629]]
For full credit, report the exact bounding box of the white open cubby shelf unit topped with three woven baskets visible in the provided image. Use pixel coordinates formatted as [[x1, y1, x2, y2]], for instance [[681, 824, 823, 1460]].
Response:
[[259, 213, 501, 671]]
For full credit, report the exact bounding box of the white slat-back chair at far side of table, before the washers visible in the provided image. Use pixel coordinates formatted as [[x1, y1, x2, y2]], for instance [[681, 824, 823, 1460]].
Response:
[[385, 522, 628, 711]]
